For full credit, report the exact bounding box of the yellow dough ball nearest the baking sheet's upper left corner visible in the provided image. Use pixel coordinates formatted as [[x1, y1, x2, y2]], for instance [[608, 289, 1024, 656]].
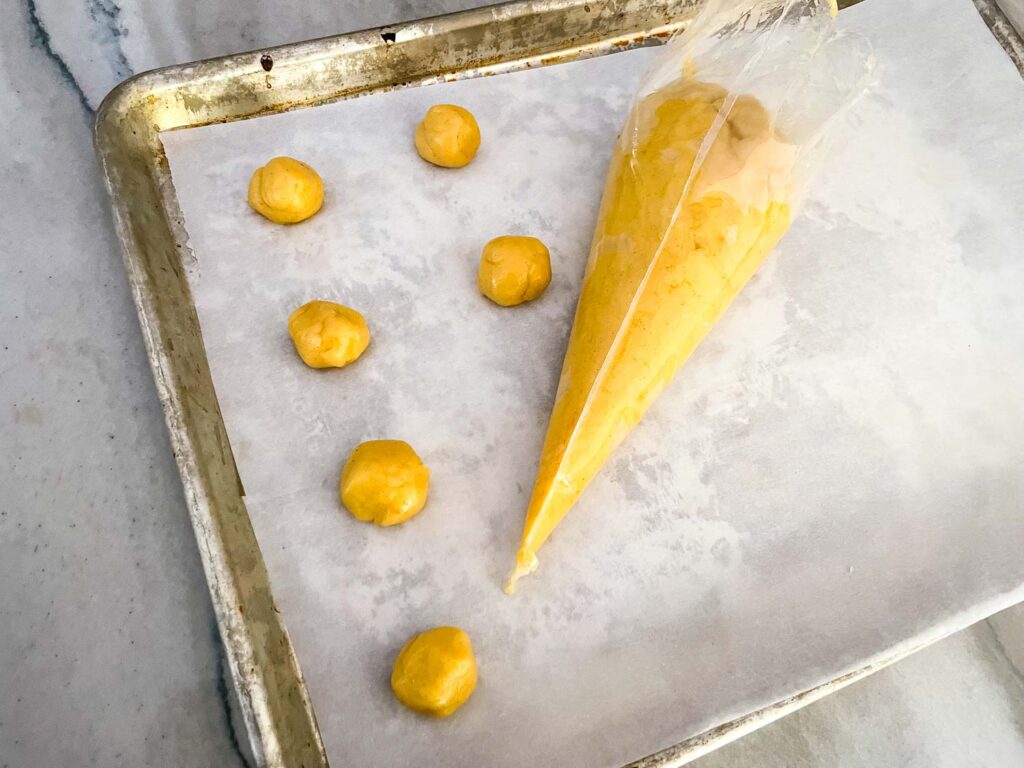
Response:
[[249, 158, 324, 224]]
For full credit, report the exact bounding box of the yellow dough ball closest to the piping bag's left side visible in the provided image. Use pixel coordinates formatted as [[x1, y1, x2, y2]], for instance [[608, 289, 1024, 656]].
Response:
[[476, 234, 551, 306]]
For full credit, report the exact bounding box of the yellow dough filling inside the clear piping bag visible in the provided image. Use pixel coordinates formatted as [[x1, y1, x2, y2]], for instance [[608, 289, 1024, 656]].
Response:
[[505, 77, 796, 594]]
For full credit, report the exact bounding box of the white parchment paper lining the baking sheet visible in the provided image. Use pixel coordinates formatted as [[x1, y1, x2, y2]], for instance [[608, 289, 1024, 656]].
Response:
[[164, 0, 1024, 766]]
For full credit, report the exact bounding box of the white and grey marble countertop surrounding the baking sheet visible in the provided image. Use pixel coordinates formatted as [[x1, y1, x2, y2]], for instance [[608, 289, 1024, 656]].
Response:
[[6, 0, 1024, 768]]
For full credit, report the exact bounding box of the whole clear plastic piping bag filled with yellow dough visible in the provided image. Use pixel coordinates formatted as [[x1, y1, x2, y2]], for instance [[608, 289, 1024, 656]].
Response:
[[505, 0, 872, 594]]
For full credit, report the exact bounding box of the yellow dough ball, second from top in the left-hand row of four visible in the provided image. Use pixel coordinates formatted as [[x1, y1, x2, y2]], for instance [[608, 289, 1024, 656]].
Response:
[[288, 301, 370, 368]]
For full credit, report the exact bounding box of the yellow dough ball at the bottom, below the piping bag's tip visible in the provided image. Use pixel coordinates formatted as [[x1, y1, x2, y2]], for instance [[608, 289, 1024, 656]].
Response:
[[391, 627, 476, 718]]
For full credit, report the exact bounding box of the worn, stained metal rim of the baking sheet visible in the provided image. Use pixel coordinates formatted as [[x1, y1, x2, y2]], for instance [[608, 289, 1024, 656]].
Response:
[[94, 0, 1024, 768]]
